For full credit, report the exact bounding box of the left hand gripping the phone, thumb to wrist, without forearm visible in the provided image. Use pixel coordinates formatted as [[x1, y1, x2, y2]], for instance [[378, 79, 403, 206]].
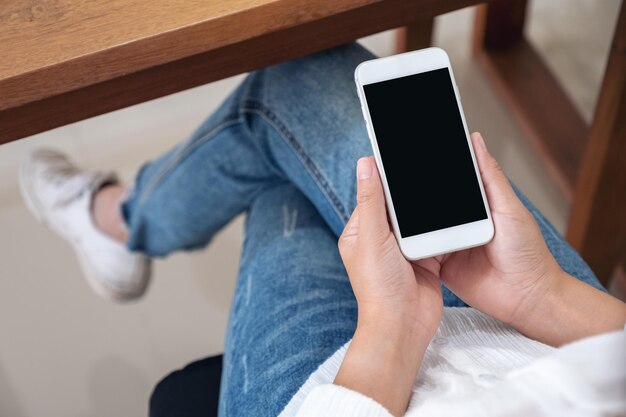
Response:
[[339, 157, 442, 334]]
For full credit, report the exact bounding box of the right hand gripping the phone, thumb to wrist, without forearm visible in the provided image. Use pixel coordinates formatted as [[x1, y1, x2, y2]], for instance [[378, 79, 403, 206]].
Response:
[[428, 133, 562, 334]]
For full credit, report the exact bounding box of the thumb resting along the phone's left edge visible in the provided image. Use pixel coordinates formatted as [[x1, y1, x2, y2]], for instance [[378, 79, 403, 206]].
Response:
[[357, 156, 389, 242]]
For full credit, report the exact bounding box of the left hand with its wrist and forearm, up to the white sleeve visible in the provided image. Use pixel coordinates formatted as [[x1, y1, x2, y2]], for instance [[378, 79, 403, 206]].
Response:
[[335, 157, 443, 415]]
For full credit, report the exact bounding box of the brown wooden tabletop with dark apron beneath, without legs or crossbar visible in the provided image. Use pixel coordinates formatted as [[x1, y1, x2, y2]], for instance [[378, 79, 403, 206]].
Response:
[[0, 0, 478, 143]]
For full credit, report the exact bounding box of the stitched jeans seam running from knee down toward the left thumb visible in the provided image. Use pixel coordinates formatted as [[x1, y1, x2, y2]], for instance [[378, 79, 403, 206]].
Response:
[[241, 100, 348, 223]]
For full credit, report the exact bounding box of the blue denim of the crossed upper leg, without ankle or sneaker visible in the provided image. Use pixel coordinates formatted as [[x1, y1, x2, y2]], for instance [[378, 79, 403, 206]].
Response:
[[119, 44, 599, 292]]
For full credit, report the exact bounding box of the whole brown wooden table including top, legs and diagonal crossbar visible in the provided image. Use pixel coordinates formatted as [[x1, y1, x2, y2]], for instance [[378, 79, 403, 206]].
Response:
[[0, 0, 626, 278]]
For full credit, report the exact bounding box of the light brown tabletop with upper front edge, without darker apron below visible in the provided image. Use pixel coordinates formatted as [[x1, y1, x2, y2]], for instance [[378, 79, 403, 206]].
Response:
[[0, 0, 376, 109]]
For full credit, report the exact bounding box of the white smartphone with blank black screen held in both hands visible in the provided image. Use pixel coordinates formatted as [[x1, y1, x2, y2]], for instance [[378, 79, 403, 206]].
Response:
[[355, 48, 494, 260]]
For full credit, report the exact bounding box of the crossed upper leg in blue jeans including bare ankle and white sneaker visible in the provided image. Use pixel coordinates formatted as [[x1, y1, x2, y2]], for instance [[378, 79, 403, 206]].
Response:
[[22, 44, 599, 305]]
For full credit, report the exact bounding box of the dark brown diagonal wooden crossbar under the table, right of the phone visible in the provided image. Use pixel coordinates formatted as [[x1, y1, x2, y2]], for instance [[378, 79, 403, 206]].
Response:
[[474, 3, 589, 198]]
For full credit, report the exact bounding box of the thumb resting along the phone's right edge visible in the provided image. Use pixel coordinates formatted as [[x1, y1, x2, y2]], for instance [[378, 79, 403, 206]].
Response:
[[472, 132, 519, 211]]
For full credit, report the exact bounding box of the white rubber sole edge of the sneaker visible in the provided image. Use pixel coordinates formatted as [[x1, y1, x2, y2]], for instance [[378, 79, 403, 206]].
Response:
[[19, 159, 150, 302]]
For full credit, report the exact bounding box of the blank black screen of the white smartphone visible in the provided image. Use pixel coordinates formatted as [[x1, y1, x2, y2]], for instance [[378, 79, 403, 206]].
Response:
[[363, 68, 487, 238]]
